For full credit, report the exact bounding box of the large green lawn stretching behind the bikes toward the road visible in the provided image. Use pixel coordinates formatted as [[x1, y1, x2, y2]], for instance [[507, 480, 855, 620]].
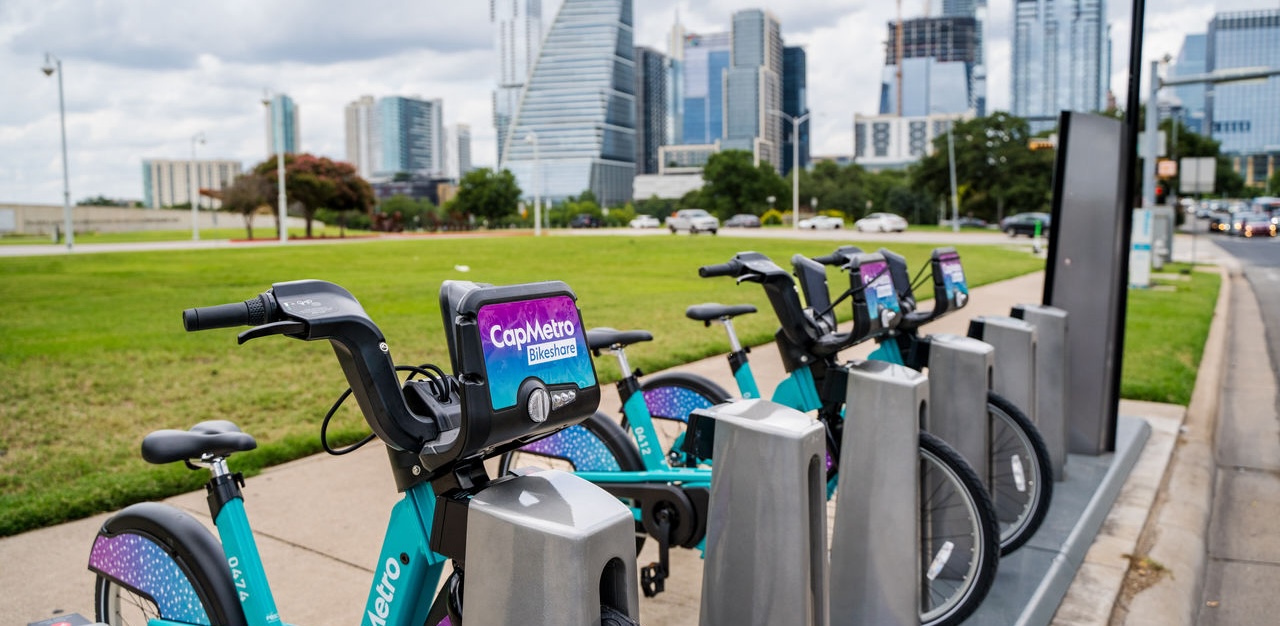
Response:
[[0, 236, 1212, 536]]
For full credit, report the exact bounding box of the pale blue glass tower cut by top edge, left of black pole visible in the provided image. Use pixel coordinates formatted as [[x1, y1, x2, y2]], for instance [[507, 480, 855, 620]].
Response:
[[1010, 0, 1110, 128]]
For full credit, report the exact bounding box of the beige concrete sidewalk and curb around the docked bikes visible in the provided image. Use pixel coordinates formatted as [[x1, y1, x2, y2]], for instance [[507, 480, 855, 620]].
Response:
[[0, 241, 1233, 626]]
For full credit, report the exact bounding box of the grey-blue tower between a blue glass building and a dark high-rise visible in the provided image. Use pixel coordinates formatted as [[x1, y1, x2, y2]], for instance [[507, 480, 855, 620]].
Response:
[[727, 9, 782, 169]]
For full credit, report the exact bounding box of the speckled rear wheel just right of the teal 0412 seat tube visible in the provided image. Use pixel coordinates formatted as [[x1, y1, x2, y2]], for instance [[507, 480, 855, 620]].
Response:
[[637, 371, 732, 467]]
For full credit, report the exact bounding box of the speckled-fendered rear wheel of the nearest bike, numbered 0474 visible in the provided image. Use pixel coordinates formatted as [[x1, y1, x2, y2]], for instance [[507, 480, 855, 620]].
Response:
[[90, 503, 247, 626]]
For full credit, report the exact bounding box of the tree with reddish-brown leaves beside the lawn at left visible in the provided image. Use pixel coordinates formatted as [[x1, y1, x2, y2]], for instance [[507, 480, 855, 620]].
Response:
[[253, 154, 375, 238]]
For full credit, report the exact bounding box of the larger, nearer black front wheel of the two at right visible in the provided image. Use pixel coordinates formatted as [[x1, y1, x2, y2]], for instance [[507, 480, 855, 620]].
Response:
[[918, 433, 1000, 626]]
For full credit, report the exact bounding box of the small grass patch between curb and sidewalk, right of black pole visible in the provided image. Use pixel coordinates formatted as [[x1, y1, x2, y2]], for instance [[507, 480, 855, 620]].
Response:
[[1120, 264, 1221, 406]]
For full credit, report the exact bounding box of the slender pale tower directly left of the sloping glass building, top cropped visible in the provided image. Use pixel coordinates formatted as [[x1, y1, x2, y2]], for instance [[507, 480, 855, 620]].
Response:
[[489, 0, 543, 168]]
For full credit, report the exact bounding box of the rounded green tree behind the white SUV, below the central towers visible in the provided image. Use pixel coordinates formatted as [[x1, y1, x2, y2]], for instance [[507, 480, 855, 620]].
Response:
[[700, 150, 791, 219]]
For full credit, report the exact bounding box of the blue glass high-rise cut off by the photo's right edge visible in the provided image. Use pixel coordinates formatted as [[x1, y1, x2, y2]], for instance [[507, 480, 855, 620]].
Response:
[[1204, 9, 1280, 186]]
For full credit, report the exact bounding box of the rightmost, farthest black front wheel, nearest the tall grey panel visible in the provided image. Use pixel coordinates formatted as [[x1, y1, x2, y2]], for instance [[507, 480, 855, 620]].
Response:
[[987, 392, 1053, 554]]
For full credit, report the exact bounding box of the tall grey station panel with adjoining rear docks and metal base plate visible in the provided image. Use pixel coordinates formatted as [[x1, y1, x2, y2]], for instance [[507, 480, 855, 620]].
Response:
[[934, 111, 1151, 625]]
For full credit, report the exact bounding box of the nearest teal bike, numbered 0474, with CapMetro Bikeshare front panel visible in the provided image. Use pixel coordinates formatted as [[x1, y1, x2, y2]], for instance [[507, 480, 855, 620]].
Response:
[[88, 280, 637, 626]]
